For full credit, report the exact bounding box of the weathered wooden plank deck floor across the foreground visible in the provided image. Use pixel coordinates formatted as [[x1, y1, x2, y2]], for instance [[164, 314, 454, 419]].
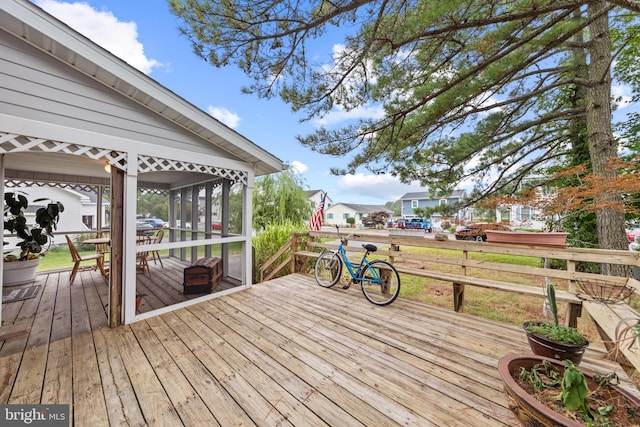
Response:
[[0, 272, 640, 427]]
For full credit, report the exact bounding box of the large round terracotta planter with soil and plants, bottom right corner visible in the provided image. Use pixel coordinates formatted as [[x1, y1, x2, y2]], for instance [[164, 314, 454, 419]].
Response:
[[498, 354, 640, 427]]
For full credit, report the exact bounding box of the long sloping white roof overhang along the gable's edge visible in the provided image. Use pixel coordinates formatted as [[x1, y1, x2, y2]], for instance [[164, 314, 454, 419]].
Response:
[[0, 0, 285, 176]]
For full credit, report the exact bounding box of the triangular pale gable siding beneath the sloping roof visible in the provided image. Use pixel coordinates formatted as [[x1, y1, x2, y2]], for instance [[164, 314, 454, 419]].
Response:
[[0, 31, 233, 159]]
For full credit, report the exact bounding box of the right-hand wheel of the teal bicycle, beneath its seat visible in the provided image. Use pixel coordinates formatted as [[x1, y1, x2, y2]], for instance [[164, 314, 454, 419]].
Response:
[[360, 261, 400, 305]]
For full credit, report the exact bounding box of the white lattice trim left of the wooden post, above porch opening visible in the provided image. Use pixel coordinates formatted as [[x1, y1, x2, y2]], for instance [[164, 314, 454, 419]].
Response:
[[0, 132, 127, 170]]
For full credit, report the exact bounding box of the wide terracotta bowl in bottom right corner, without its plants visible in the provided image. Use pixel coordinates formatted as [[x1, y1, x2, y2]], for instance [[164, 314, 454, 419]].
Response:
[[498, 354, 640, 427]]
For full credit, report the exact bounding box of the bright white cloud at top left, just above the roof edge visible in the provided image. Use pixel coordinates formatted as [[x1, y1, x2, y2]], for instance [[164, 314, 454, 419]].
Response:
[[36, 0, 162, 74]]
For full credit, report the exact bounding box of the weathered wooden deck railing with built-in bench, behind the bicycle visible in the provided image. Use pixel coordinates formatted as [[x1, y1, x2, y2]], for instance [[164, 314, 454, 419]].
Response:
[[260, 231, 640, 371]]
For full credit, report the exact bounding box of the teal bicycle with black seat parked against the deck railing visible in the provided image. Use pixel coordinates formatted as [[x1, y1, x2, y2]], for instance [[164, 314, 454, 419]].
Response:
[[314, 225, 400, 305]]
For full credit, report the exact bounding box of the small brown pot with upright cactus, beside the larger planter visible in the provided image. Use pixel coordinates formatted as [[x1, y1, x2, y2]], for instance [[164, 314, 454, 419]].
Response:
[[522, 283, 589, 365]]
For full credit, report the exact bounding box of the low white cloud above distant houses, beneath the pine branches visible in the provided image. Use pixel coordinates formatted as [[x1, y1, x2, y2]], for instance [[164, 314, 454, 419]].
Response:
[[334, 173, 425, 204]]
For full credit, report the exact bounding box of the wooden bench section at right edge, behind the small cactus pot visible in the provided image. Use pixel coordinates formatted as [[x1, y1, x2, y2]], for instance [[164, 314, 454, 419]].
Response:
[[583, 301, 640, 372]]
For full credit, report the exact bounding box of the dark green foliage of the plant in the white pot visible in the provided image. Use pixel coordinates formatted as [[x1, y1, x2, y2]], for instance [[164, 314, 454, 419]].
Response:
[[4, 192, 64, 261]]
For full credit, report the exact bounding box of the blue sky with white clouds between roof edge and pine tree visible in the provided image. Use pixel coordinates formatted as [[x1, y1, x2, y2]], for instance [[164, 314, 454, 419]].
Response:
[[33, 0, 428, 204]]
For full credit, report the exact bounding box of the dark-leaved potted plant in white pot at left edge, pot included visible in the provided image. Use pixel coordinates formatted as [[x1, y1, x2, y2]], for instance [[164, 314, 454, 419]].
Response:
[[3, 192, 64, 286]]
